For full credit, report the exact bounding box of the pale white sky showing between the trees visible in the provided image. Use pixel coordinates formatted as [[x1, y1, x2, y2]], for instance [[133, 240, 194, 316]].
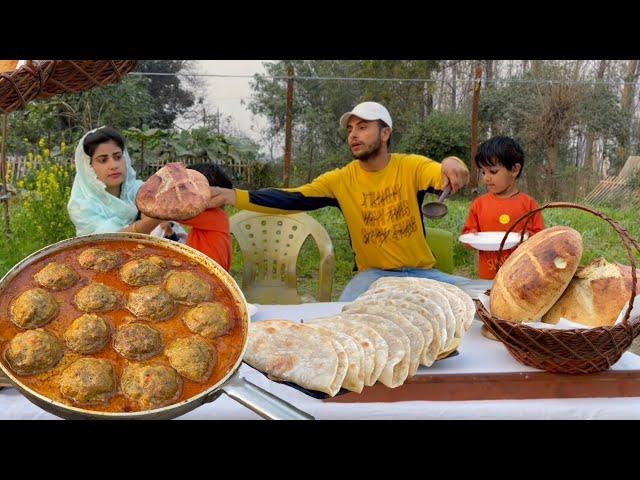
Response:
[[196, 60, 276, 141]]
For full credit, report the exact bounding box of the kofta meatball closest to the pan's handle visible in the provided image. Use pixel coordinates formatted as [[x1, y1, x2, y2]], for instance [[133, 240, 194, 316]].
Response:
[[164, 335, 216, 382]]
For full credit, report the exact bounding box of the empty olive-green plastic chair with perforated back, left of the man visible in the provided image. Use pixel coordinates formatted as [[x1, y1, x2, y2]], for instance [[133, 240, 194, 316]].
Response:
[[230, 211, 336, 305]]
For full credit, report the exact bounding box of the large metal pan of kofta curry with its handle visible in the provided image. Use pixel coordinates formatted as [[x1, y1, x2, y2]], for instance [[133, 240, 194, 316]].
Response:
[[0, 233, 313, 419]]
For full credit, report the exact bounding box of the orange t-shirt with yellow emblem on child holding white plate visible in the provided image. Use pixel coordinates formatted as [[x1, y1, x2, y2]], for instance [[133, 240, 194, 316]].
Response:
[[462, 192, 544, 280]]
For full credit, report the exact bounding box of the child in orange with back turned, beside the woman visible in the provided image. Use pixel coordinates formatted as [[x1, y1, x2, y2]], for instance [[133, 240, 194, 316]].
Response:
[[180, 163, 233, 271]]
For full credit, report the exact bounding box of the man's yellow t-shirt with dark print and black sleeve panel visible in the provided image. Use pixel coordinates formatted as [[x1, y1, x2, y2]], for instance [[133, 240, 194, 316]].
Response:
[[236, 153, 442, 271]]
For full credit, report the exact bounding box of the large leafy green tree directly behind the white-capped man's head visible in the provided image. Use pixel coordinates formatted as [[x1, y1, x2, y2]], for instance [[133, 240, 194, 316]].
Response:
[[248, 60, 438, 183]]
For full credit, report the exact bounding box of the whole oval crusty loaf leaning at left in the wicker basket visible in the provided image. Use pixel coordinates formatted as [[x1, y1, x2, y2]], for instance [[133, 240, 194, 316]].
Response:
[[491, 226, 582, 322]]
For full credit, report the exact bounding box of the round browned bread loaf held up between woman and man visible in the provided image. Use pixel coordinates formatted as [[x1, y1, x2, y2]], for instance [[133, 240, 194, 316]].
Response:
[[136, 163, 211, 220]]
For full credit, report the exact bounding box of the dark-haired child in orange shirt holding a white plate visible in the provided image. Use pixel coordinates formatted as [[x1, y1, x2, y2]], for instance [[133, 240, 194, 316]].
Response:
[[462, 137, 544, 280]]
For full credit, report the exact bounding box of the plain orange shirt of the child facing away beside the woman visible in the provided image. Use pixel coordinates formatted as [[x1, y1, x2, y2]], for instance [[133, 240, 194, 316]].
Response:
[[180, 208, 231, 271]]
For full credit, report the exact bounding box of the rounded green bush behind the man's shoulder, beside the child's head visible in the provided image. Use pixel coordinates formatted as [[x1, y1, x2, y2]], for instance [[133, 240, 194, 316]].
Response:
[[396, 113, 471, 162]]
